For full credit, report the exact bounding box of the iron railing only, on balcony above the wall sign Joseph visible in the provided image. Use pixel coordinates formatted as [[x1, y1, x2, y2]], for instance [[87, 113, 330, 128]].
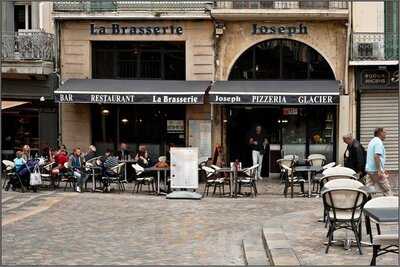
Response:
[[214, 0, 348, 9]]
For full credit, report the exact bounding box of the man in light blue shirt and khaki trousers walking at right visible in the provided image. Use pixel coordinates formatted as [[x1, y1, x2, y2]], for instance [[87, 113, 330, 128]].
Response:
[[365, 128, 392, 196]]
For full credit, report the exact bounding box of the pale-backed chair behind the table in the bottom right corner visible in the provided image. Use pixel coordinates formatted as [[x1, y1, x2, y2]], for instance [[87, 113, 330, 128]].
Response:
[[364, 196, 399, 266]]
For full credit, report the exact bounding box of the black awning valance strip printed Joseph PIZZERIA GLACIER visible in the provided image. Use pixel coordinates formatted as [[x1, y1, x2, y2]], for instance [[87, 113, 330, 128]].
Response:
[[210, 94, 339, 105]]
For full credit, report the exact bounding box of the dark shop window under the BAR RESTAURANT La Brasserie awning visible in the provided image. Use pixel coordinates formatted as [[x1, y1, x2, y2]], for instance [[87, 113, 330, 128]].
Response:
[[92, 105, 185, 156]]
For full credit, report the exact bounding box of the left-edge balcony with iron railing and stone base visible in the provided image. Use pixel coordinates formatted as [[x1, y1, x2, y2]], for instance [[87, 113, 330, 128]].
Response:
[[1, 30, 55, 75]]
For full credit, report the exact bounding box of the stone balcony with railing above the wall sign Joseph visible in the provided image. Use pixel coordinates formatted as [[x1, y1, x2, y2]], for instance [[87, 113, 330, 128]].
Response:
[[211, 0, 348, 20]]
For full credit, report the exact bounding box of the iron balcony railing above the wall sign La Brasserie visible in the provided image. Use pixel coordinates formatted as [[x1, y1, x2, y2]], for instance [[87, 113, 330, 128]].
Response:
[[53, 0, 214, 12]]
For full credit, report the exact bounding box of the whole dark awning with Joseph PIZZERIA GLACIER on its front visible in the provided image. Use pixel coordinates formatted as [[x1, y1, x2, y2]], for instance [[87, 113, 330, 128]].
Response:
[[209, 80, 340, 105]]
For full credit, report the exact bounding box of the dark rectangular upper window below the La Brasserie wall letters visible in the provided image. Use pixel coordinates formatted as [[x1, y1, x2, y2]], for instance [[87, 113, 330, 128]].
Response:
[[93, 42, 186, 80]]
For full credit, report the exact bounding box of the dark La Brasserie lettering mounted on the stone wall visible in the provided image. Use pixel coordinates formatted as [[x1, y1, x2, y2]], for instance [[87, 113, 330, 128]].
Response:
[[90, 23, 183, 35]]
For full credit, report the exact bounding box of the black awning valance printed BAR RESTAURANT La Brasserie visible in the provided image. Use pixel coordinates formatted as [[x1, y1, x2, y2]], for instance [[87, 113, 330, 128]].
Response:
[[55, 93, 203, 104]]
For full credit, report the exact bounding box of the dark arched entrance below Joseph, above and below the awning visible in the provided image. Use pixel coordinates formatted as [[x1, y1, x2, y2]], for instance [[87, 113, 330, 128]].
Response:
[[226, 39, 336, 176]]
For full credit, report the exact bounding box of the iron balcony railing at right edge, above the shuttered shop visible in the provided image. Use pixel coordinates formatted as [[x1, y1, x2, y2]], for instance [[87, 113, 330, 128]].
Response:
[[351, 32, 399, 61]]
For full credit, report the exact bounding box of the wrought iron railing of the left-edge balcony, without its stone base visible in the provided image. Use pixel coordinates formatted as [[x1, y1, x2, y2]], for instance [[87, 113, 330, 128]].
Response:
[[1, 31, 55, 61]]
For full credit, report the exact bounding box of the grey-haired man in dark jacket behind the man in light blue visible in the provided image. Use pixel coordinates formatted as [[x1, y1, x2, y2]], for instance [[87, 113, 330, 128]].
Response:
[[343, 133, 365, 178]]
